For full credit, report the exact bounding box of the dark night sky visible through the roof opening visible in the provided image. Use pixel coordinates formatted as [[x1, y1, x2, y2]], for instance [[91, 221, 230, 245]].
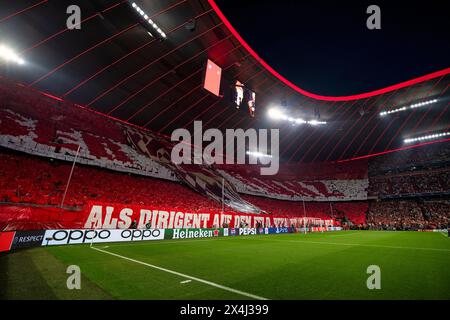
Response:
[[216, 0, 450, 95]]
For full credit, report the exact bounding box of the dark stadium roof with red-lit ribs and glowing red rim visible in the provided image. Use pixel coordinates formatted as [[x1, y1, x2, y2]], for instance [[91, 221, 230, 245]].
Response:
[[0, 0, 450, 163]]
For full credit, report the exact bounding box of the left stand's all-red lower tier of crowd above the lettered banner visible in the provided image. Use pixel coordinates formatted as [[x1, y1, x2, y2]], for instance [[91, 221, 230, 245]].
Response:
[[0, 150, 221, 212]]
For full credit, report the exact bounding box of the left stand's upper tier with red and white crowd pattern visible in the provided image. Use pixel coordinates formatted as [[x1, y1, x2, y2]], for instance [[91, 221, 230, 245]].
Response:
[[0, 75, 176, 180]]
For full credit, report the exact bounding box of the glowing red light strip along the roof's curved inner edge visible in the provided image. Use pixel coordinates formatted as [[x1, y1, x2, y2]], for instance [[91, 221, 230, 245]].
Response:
[[208, 0, 450, 101]]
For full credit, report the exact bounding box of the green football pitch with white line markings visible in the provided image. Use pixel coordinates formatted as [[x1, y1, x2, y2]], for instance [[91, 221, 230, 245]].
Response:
[[0, 231, 450, 300]]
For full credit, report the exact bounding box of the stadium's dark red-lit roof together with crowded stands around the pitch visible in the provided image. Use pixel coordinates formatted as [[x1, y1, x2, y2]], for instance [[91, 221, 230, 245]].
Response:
[[0, 0, 450, 298]]
